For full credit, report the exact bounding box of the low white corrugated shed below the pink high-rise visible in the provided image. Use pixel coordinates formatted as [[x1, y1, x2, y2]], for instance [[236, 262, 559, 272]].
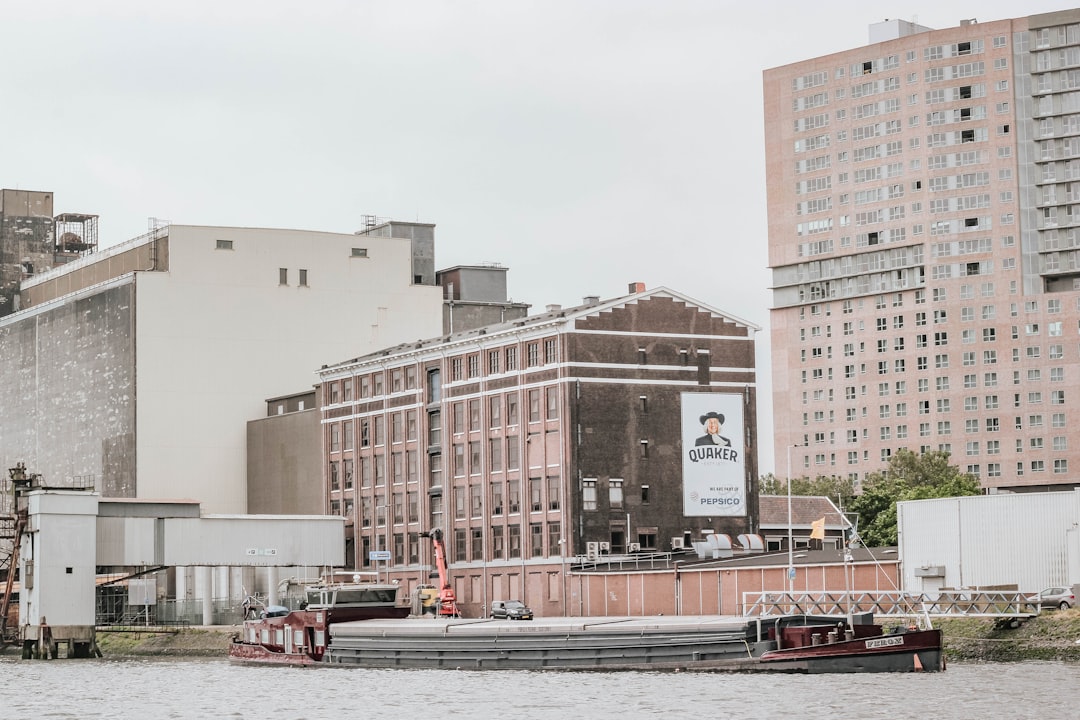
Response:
[[896, 490, 1080, 596]]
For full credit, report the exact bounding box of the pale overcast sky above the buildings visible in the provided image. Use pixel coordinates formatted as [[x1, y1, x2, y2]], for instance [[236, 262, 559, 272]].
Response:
[[0, 0, 1071, 473]]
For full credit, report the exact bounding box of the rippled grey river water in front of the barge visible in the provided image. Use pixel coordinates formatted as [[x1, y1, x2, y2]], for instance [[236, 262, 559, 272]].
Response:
[[0, 656, 1080, 720]]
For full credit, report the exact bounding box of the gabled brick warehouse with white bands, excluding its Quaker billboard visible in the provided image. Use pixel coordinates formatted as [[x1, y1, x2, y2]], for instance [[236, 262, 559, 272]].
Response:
[[320, 284, 759, 616]]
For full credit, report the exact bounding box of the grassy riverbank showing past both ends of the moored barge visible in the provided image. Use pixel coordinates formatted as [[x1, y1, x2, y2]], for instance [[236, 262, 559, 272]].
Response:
[[82, 609, 1080, 663]]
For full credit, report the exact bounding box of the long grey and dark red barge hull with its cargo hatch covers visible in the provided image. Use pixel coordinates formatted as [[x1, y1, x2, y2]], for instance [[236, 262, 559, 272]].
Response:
[[230, 615, 945, 674]]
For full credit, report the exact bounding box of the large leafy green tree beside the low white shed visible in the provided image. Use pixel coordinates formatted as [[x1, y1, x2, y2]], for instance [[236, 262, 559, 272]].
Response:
[[851, 449, 982, 547]]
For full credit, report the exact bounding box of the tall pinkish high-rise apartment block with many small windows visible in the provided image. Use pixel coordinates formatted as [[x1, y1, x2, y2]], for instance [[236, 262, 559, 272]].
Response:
[[765, 10, 1080, 492]]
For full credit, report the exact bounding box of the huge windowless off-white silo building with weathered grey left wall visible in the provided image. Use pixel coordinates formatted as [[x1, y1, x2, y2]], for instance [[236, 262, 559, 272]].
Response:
[[0, 216, 443, 513]]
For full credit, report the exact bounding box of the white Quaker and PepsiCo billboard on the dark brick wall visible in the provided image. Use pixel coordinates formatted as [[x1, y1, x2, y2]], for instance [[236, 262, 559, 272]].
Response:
[[681, 393, 746, 517]]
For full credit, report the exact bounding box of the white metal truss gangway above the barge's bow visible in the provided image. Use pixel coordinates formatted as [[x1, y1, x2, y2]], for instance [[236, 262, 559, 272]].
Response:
[[742, 590, 1039, 619]]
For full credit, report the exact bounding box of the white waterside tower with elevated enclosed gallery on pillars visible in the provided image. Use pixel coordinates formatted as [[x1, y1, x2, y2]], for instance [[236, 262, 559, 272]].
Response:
[[16, 478, 345, 657]]
